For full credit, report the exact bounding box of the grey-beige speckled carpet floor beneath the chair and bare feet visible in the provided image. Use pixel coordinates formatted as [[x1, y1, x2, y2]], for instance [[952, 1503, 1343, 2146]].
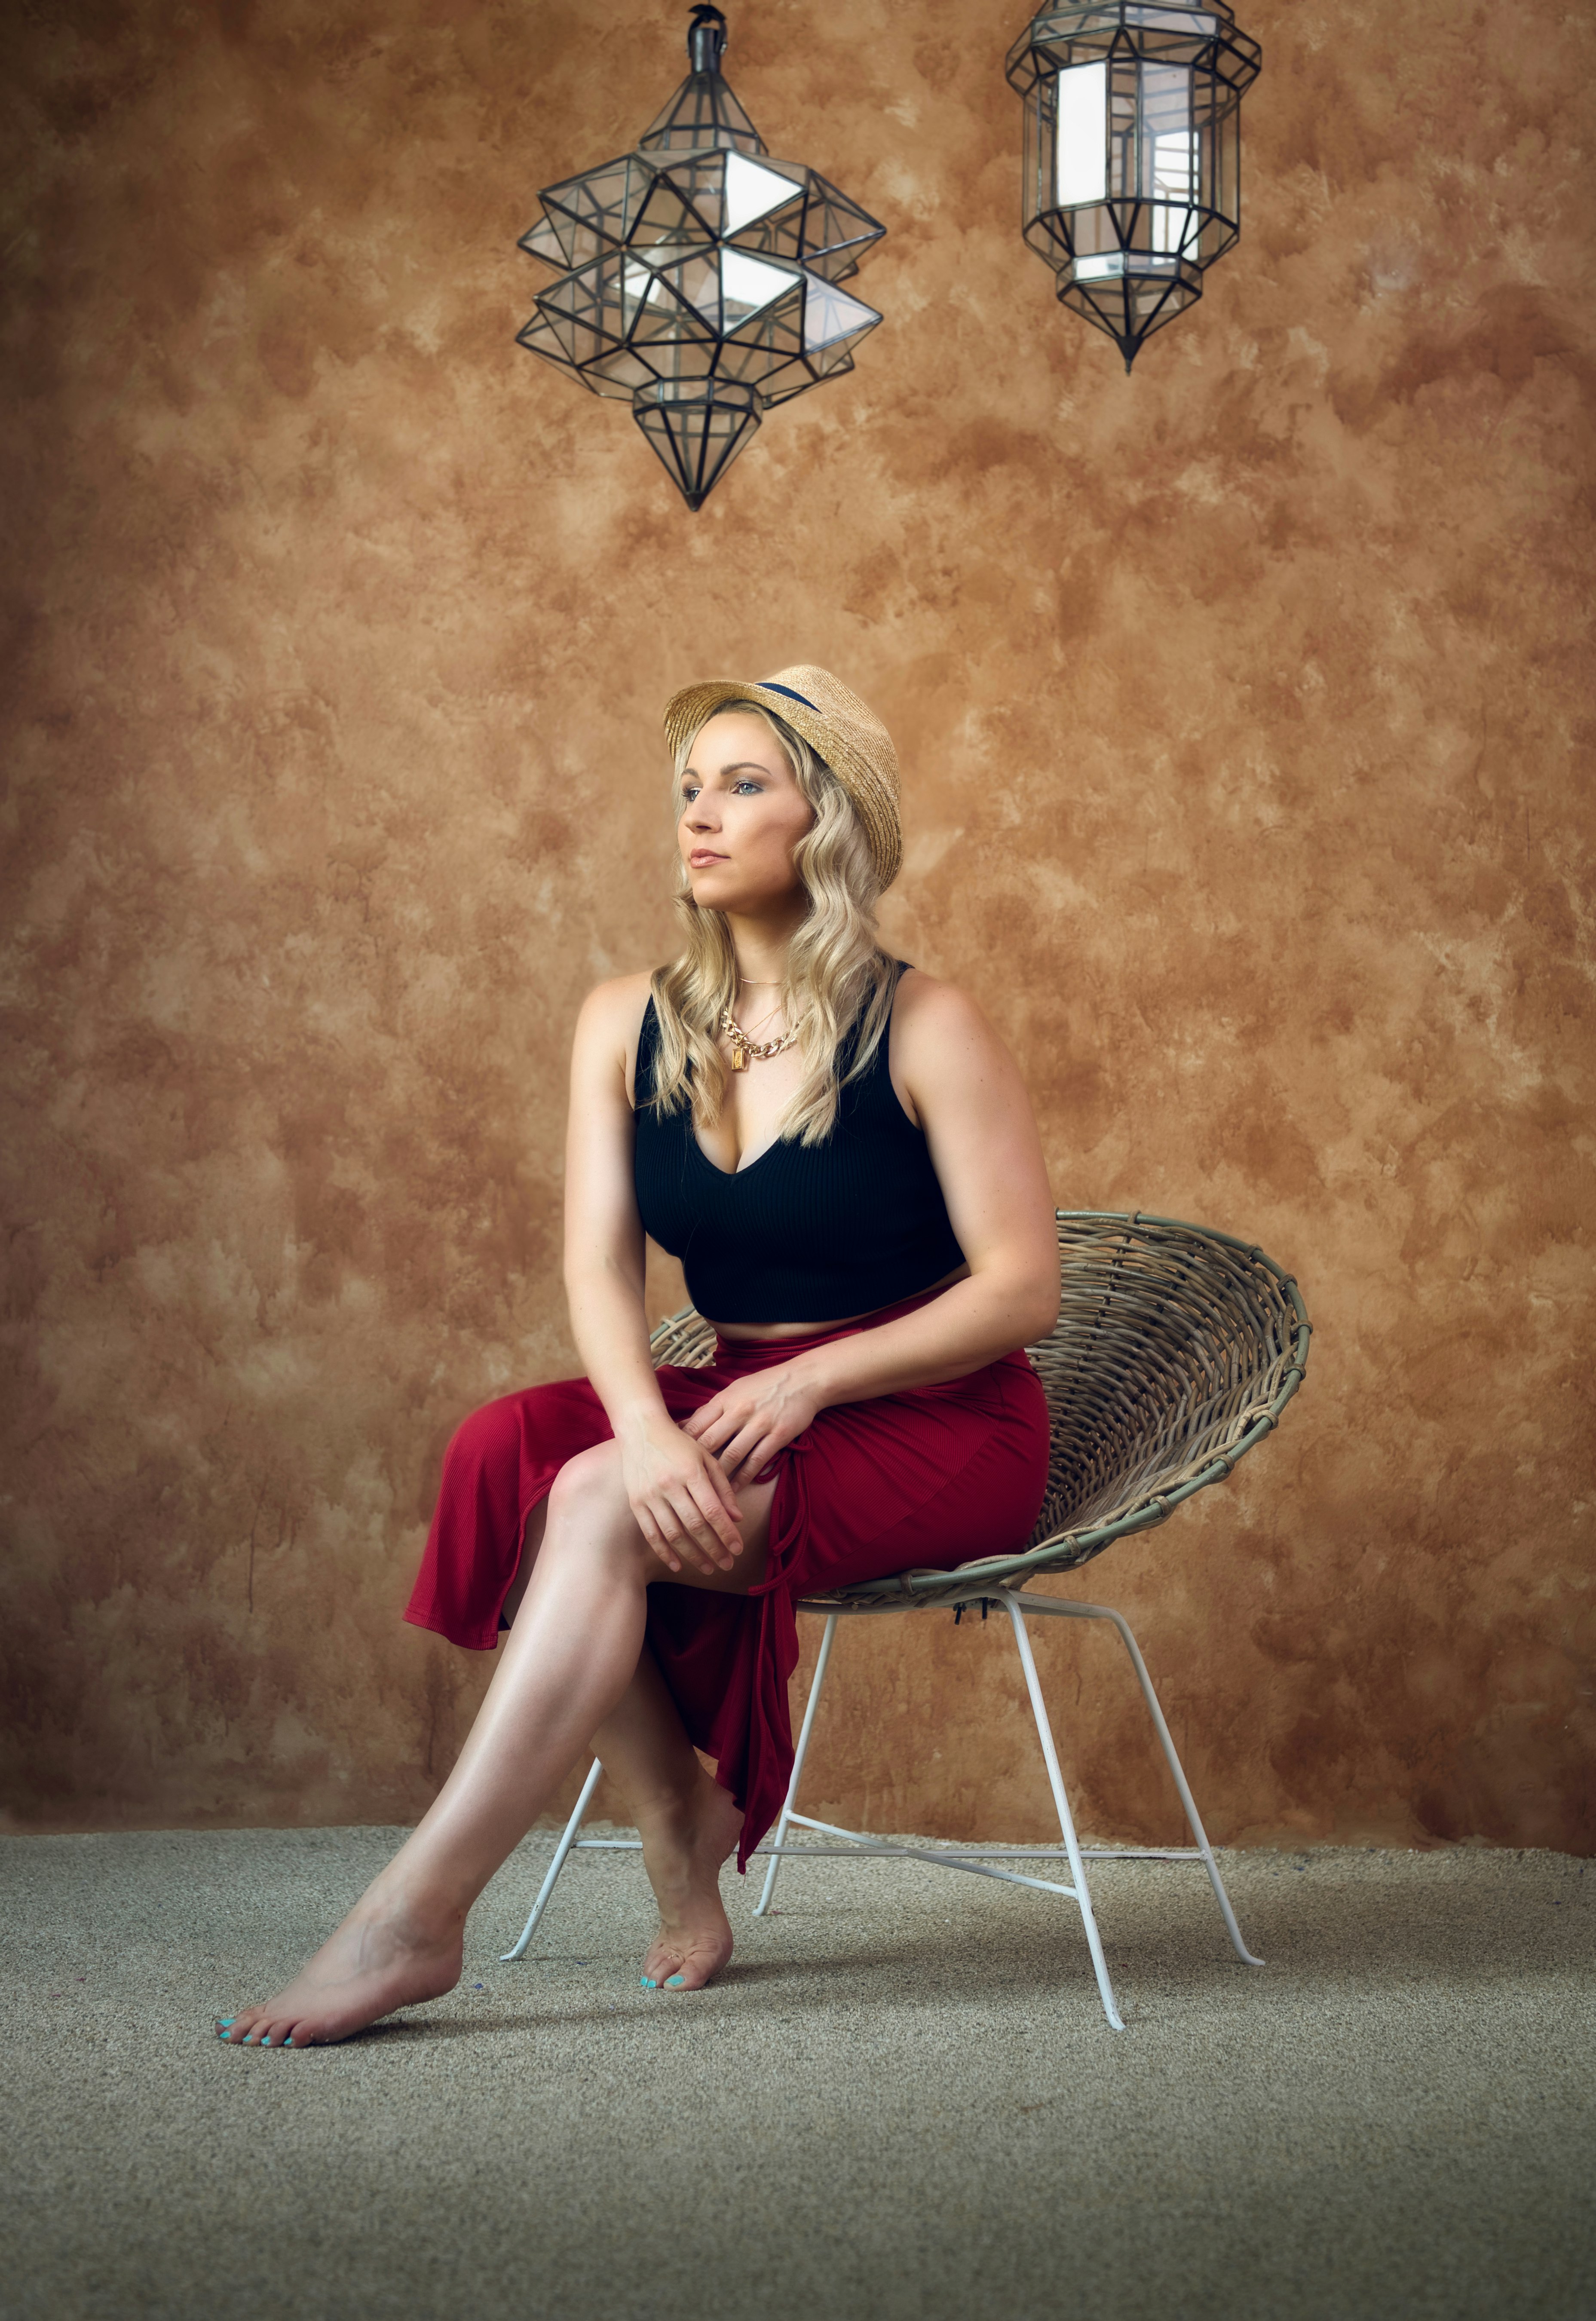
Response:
[[0, 1829, 1596, 2321]]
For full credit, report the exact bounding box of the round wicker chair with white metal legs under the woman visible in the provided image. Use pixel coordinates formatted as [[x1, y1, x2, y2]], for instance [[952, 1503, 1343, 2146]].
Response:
[[506, 1209, 1311, 2031]]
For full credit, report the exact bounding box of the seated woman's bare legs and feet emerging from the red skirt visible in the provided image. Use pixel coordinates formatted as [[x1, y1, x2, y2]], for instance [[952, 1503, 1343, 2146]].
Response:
[[218, 1441, 775, 2047]]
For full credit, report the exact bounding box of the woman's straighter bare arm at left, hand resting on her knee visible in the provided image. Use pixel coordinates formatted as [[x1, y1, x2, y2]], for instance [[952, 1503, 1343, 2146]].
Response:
[[566, 975, 742, 1571]]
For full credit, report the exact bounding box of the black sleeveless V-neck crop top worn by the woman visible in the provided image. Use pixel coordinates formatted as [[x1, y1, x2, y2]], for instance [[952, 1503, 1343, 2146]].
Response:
[[633, 961, 965, 1323]]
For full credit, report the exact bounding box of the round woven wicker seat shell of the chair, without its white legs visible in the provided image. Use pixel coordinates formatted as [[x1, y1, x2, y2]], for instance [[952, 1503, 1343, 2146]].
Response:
[[649, 1209, 1311, 1604]]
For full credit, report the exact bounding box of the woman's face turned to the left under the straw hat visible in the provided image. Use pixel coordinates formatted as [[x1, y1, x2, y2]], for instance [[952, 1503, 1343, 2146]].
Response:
[[677, 710, 814, 915]]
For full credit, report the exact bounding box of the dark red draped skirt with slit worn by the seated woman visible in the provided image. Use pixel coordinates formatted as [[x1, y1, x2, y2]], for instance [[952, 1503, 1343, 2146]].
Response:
[[406, 1300, 1048, 1868]]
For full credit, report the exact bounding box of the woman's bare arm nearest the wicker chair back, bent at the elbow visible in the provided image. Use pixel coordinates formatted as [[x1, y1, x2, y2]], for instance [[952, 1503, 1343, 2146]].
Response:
[[686, 975, 1058, 1474]]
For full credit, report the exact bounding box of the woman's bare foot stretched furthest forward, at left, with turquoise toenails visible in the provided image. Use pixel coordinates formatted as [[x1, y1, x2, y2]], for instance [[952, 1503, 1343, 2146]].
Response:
[[218, 1894, 466, 2047]]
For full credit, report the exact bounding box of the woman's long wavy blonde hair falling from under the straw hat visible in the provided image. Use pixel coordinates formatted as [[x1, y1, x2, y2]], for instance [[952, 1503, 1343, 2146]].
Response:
[[649, 701, 895, 1144]]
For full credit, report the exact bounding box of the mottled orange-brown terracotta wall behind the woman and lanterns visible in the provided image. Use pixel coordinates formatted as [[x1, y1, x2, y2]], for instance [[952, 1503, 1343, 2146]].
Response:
[[0, 0, 1591, 1847]]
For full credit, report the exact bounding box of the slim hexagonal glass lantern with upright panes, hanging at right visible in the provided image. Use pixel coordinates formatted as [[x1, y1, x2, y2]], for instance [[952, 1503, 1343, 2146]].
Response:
[[1007, 0, 1262, 371]]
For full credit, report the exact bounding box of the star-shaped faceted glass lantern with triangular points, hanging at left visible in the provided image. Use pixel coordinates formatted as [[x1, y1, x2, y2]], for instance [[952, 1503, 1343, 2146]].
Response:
[[517, 7, 884, 508]]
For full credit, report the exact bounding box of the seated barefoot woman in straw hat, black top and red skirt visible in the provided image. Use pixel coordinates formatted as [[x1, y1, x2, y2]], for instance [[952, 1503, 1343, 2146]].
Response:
[[218, 668, 1058, 2047]]
